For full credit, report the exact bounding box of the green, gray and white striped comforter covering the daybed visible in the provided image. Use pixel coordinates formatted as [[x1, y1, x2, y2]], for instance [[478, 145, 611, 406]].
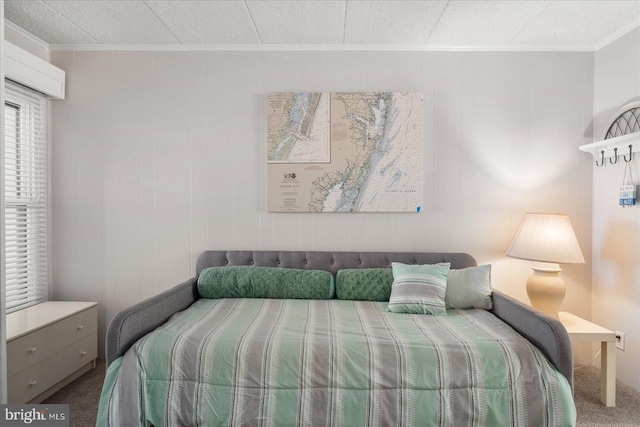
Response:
[[97, 299, 576, 427]]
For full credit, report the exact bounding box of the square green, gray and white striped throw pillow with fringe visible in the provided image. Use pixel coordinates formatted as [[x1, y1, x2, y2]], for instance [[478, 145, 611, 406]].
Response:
[[387, 262, 449, 316]]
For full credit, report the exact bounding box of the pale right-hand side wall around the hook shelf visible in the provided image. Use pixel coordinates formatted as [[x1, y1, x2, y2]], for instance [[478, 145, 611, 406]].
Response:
[[592, 28, 640, 390]]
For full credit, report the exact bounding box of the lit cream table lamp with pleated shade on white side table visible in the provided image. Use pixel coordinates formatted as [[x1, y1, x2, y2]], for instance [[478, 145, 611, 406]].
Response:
[[507, 213, 584, 319]]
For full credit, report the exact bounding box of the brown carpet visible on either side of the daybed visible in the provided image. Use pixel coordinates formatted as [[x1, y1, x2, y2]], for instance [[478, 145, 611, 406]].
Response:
[[43, 361, 640, 427]]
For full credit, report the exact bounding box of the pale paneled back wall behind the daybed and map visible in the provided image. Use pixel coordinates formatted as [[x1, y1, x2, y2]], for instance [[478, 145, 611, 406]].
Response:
[[51, 51, 593, 362]]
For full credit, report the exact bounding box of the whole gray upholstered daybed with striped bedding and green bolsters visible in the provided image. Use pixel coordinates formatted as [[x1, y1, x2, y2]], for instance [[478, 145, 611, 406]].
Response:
[[97, 251, 576, 426]]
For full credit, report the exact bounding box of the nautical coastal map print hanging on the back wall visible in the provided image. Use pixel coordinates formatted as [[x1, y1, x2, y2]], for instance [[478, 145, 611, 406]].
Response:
[[266, 92, 423, 212]]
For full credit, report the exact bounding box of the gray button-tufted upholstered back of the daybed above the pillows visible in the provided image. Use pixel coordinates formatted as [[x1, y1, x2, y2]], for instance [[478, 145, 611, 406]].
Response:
[[196, 251, 477, 276]]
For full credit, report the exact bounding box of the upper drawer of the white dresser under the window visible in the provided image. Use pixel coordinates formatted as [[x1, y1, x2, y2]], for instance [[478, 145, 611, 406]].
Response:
[[7, 307, 98, 377]]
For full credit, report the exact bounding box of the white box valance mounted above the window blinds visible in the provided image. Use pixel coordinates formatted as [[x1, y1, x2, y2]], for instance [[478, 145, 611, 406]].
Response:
[[4, 41, 65, 99]]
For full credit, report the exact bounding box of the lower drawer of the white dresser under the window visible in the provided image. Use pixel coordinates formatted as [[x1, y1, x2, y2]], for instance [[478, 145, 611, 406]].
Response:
[[7, 333, 98, 403]]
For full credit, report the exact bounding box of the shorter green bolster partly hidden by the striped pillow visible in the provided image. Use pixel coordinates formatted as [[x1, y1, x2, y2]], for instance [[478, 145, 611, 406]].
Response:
[[336, 268, 393, 301]]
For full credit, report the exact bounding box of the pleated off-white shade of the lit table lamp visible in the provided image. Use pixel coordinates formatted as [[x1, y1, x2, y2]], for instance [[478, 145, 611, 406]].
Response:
[[507, 213, 584, 264]]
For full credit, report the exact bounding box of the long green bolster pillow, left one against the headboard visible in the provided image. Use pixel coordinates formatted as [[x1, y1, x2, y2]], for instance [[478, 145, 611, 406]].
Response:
[[198, 265, 335, 299]]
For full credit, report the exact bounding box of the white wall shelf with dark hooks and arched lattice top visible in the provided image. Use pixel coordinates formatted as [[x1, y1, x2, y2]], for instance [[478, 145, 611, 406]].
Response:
[[579, 101, 640, 167]]
